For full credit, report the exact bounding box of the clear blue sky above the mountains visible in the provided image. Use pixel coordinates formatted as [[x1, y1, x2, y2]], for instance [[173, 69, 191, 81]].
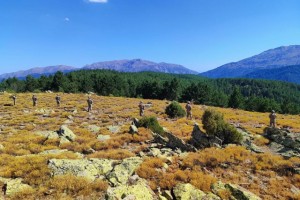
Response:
[[0, 0, 300, 74]]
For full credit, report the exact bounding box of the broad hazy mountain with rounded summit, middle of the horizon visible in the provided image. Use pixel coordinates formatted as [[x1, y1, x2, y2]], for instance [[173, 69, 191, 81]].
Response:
[[82, 59, 198, 74]]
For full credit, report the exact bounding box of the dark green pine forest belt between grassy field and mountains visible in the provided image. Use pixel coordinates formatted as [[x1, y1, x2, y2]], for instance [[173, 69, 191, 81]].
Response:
[[0, 70, 300, 114]]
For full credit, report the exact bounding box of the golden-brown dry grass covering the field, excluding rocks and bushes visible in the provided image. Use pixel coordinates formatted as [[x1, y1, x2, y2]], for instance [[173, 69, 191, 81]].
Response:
[[0, 93, 300, 199]]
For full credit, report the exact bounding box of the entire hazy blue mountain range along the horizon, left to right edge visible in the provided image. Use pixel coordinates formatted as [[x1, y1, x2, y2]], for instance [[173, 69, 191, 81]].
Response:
[[0, 45, 300, 83]]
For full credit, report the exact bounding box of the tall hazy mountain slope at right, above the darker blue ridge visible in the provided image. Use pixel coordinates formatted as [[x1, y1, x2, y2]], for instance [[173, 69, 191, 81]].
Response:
[[200, 45, 300, 78]]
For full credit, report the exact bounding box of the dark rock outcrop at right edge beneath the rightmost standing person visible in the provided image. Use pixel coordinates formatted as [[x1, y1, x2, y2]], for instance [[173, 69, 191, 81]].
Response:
[[264, 128, 300, 158]]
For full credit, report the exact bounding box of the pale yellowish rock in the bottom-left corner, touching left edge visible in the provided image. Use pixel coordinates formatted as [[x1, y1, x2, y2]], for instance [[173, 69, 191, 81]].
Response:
[[0, 177, 33, 196]]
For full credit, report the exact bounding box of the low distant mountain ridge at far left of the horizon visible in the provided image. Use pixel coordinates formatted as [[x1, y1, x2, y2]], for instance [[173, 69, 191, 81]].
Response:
[[0, 65, 77, 80]]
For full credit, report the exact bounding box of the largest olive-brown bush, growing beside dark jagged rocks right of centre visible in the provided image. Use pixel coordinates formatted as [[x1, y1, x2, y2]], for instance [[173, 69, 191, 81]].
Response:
[[202, 109, 243, 144]]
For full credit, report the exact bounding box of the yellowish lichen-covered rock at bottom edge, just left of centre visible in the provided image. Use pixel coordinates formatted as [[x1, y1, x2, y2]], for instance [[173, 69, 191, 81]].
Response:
[[106, 179, 157, 200]]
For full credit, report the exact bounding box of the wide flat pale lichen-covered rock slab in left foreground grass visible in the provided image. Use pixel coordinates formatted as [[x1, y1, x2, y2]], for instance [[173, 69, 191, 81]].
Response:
[[48, 159, 114, 181]]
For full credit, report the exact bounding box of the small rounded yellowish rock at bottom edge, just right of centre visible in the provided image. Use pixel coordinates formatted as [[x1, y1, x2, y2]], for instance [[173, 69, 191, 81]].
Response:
[[173, 183, 206, 200]]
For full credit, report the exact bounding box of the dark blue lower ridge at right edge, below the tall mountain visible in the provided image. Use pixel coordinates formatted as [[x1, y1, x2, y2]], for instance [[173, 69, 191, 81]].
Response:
[[244, 65, 300, 84]]
